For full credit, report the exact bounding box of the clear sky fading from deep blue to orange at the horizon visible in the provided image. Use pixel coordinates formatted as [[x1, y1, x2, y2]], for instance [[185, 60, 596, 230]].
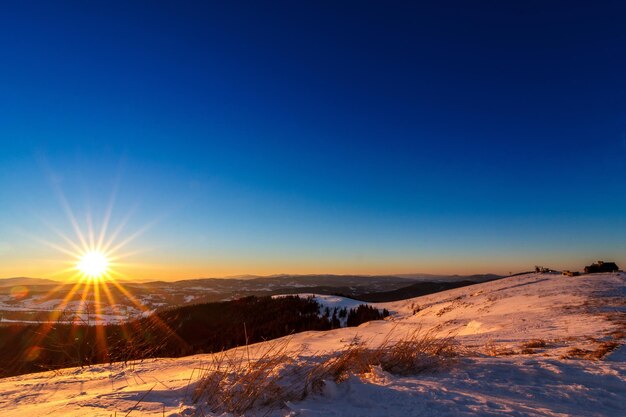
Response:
[[0, 0, 626, 279]]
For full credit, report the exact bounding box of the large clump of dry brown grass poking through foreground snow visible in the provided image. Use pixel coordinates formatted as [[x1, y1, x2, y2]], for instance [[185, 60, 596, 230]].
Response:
[[192, 329, 460, 415]]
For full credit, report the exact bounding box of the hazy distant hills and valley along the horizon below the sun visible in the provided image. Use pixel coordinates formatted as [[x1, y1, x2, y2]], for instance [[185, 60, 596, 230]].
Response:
[[0, 274, 500, 323]]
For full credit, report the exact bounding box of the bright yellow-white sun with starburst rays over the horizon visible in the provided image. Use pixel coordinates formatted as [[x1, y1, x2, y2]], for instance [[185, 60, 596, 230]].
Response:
[[17, 180, 185, 368]]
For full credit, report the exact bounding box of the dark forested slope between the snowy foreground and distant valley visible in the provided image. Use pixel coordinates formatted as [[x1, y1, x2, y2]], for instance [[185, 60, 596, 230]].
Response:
[[0, 296, 389, 377]]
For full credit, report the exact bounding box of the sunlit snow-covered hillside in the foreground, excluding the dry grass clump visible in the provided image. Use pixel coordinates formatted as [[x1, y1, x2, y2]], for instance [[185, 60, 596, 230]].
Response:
[[0, 274, 626, 416]]
